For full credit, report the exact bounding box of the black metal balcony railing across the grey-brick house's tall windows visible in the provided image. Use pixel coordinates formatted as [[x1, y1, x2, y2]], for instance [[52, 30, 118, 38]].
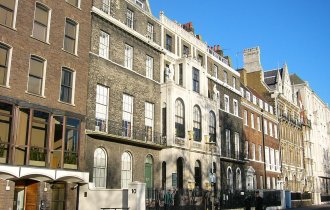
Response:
[[87, 119, 166, 146]]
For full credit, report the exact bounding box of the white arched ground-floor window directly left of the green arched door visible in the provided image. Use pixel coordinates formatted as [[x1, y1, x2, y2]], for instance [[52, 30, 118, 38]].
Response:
[[121, 152, 132, 189]]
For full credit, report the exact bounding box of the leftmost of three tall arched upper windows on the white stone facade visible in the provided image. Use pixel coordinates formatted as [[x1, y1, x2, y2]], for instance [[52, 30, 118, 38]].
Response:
[[175, 99, 185, 138]]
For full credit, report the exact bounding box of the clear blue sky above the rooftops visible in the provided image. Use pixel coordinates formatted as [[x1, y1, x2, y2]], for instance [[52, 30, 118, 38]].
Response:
[[149, 0, 330, 103]]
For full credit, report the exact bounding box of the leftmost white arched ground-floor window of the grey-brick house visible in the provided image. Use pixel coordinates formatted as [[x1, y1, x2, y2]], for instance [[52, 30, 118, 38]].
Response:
[[93, 148, 107, 188]]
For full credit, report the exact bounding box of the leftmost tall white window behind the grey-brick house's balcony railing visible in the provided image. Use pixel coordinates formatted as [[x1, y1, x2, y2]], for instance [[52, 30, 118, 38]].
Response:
[[95, 84, 109, 132]]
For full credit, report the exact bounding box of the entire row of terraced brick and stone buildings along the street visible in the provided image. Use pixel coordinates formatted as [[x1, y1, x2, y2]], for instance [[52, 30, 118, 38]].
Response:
[[0, 0, 330, 210]]
